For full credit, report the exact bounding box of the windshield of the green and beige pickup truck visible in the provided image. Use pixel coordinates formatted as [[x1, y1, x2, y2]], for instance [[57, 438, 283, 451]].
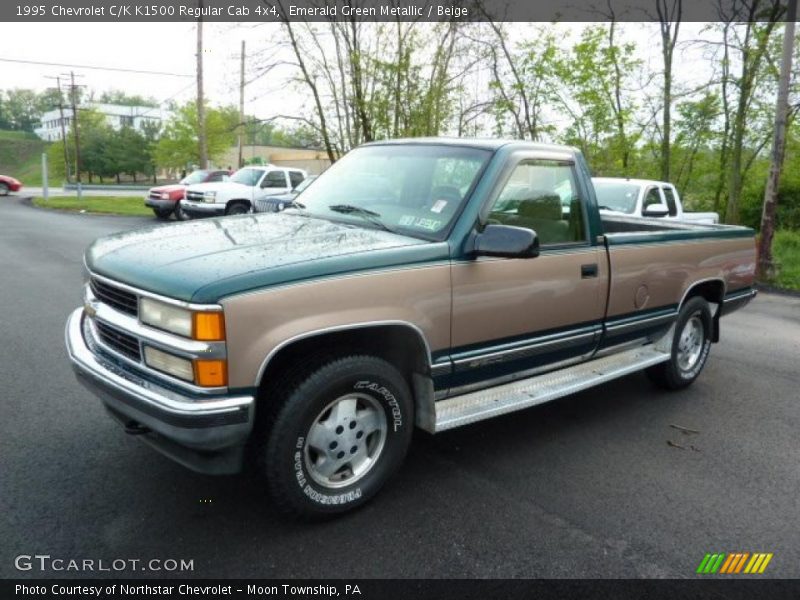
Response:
[[292, 144, 491, 239]]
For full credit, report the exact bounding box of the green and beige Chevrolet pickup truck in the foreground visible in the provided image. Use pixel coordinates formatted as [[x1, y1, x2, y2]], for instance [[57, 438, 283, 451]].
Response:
[[66, 139, 755, 517]]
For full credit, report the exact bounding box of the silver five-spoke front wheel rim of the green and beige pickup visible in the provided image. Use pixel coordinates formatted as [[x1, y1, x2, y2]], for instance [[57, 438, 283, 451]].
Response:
[[304, 394, 388, 488]]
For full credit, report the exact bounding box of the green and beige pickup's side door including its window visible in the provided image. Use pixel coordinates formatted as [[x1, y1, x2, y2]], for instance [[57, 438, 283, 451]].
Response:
[[446, 154, 608, 394]]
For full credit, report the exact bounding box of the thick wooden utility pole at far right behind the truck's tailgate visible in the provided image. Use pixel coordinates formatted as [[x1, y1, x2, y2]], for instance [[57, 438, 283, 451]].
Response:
[[758, 0, 797, 281]]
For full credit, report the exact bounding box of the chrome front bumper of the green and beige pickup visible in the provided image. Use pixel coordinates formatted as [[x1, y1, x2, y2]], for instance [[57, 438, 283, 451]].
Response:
[[65, 308, 255, 473]]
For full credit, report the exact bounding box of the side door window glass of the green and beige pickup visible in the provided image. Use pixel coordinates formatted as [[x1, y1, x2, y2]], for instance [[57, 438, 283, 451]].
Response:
[[489, 160, 587, 246]]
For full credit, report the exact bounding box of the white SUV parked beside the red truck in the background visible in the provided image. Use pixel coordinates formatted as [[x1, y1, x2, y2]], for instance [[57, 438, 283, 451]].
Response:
[[180, 165, 308, 217]]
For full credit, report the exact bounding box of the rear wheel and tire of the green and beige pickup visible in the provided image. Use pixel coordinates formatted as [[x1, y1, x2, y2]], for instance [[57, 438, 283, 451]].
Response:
[[645, 296, 713, 390]]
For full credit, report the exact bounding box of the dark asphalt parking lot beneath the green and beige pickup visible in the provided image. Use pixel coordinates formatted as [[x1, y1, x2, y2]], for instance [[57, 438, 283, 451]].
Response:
[[0, 198, 800, 578]]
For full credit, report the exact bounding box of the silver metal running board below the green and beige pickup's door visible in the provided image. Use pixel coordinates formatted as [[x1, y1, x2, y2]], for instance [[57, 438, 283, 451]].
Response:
[[434, 338, 671, 433]]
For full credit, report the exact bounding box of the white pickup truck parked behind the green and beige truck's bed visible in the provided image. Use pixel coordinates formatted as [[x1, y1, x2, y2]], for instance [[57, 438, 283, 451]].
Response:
[[592, 177, 719, 225]]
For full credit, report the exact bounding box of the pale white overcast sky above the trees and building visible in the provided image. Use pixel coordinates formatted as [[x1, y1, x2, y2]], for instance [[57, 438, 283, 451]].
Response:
[[0, 23, 710, 127]]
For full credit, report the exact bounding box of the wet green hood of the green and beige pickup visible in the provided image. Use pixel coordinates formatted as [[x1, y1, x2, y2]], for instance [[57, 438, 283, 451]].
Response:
[[85, 213, 448, 303]]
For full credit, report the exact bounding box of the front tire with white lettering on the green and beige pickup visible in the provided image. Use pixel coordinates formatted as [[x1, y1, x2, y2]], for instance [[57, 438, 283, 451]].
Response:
[[257, 355, 414, 519]]
